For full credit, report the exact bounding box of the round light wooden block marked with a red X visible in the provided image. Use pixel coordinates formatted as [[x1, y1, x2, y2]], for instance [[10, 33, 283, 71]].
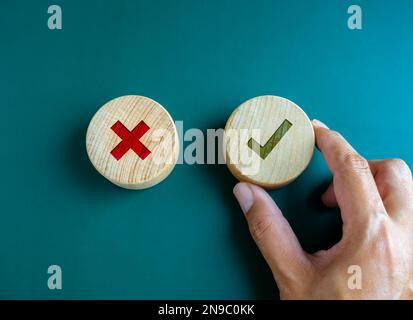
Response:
[[86, 96, 179, 190]]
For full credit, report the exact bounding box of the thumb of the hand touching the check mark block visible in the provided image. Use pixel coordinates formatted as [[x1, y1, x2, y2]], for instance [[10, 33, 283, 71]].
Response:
[[234, 183, 311, 285]]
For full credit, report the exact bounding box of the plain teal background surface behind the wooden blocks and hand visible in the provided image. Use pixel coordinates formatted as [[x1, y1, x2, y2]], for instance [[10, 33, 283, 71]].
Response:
[[0, 0, 413, 299]]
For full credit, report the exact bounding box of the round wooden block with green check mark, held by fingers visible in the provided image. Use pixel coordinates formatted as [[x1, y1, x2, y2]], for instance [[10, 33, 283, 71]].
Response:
[[224, 96, 315, 189]]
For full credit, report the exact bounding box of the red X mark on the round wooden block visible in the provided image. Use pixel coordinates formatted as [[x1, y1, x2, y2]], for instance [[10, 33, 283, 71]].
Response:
[[111, 121, 151, 161]]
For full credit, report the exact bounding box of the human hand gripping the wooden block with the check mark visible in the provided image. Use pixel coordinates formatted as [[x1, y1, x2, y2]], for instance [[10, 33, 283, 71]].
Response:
[[234, 120, 413, 299]]
